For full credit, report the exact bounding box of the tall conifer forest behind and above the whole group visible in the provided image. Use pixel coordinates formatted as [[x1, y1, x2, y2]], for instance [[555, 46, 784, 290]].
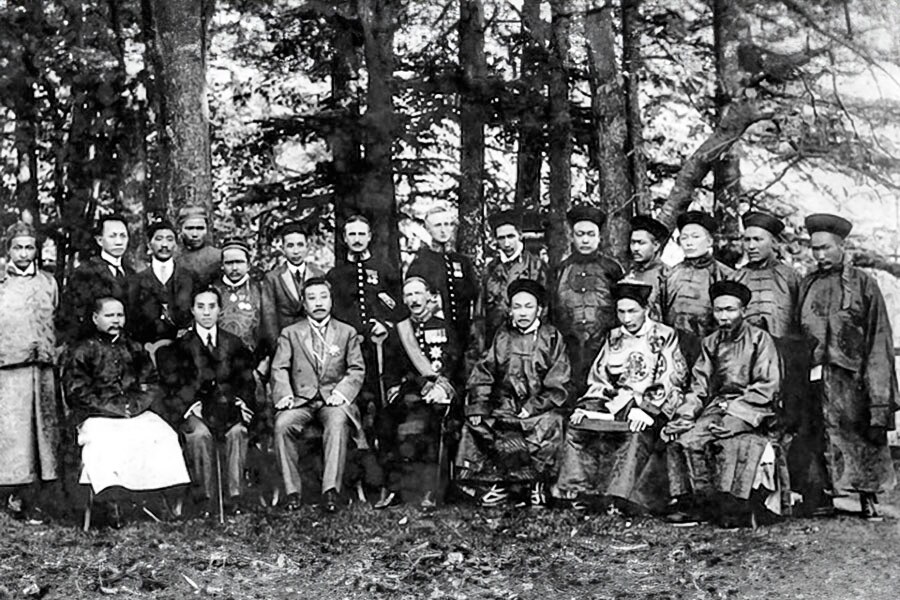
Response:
[[0, 0, 900, 278]]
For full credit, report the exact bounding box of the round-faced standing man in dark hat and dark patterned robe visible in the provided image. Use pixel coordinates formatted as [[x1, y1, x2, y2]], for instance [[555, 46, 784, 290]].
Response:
[[553, 206, 624, 395]]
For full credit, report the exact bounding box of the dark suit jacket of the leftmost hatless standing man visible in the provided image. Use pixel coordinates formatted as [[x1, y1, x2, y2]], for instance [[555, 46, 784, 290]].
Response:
[[56, 256, 134, 343]]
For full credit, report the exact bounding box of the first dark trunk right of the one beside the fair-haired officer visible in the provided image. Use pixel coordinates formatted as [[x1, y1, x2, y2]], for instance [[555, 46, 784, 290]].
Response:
[[515, 0, 547, 209]]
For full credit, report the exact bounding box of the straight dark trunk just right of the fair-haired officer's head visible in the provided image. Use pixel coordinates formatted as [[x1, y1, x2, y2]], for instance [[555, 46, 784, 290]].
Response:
[[457, 0, 487, 263]]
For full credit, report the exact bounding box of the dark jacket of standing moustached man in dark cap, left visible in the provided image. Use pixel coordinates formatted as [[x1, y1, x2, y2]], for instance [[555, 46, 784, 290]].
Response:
[[126, 263, 197, 344]]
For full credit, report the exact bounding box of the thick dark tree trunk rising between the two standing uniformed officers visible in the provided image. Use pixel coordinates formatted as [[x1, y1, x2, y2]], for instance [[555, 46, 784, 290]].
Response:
[[357, 0, 401, 278]]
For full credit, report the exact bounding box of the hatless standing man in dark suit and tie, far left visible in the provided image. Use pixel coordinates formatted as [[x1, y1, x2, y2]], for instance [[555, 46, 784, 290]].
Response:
[[57, 215, 134, 344]]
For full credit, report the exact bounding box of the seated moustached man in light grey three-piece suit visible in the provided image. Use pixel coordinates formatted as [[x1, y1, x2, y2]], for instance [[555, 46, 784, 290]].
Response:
[[272, 277, 368, 512]]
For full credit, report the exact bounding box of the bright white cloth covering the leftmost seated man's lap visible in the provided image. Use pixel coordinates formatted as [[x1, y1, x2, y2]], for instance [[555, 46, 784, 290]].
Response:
[[78, 411, 191, 494]]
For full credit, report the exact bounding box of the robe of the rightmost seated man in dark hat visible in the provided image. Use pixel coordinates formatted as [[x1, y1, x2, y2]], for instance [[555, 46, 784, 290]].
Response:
[[668, 322, 786, 500]]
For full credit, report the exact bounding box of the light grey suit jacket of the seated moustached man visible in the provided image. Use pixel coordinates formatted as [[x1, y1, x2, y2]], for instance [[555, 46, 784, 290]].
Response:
[[272, 317, 366, 408]]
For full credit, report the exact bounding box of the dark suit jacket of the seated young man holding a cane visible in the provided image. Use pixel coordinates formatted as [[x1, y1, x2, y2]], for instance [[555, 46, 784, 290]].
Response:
[[156, 327, 256, 433]]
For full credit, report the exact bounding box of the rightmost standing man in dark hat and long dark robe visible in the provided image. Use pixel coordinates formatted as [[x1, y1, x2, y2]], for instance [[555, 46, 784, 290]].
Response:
[[798, 214, 897, 517]]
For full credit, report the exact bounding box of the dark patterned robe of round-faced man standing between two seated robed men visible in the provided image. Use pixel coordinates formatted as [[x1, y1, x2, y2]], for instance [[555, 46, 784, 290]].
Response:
[[551, 252, 623, 395]]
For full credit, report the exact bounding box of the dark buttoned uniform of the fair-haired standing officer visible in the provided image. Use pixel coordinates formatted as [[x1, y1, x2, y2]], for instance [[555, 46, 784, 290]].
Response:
[[406, 246, 478, 347]]
